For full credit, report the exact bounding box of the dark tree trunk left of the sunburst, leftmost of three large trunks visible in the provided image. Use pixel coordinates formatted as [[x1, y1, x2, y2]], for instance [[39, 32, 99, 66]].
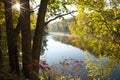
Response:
[[4, 0, 19, 73]]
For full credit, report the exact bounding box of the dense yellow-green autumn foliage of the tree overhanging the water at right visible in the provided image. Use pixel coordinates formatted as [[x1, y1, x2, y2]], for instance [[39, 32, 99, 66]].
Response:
[[70, 0, 120, 57]]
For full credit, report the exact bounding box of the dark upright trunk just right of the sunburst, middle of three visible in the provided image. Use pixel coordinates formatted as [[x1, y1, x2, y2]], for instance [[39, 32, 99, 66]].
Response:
[[20, 0, 36, 80]]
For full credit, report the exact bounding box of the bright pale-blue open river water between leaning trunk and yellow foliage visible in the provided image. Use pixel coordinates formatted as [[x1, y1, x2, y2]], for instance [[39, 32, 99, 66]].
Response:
[[41, 36, 85, 64]]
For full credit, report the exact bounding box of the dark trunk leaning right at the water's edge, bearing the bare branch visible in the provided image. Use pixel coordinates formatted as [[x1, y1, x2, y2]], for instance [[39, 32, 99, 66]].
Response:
[[32, 0, 48, 73]]
